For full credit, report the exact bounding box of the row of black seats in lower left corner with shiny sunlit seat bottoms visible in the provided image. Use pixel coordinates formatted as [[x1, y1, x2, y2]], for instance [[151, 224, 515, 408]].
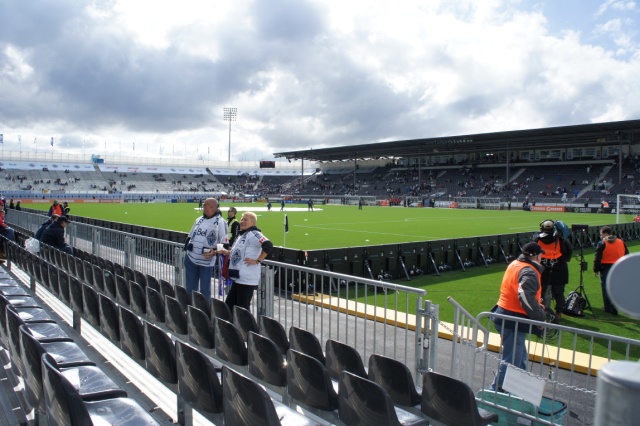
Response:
[[0, 243, 161, 425]]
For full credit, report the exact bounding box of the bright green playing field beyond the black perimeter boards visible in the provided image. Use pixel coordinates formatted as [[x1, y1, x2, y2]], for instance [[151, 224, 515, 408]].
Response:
[[25, 202, 631, 250]]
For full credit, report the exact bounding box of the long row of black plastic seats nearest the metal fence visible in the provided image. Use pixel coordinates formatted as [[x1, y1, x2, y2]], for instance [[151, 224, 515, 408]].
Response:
[[2, 233, 498, 424]]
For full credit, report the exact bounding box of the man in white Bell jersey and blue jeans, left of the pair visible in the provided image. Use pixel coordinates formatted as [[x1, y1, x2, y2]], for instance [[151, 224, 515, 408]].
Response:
[[184, 198, 227, 300]]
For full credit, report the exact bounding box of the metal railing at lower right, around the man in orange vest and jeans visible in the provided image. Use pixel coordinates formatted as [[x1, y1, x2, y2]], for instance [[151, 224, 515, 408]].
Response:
[[440, 298, 640, 425]]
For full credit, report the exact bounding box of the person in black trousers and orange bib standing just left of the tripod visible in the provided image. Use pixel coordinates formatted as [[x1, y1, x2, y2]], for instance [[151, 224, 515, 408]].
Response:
[[533, 220, 573, 320]]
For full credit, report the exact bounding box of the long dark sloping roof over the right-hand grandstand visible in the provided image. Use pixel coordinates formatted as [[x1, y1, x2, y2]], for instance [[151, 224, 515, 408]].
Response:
[[274, 120, 640, 162]]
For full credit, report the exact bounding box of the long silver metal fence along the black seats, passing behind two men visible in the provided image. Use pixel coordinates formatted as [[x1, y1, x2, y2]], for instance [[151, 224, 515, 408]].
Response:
[[5, 211, 430, 379]]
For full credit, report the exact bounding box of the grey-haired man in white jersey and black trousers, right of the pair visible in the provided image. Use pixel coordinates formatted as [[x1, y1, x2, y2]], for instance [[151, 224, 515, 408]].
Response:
[[222, 212, 273, 312]]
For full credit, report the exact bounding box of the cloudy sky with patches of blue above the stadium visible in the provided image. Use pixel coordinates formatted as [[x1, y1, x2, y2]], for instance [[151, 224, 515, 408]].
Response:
[[0, 0, 640, 161]]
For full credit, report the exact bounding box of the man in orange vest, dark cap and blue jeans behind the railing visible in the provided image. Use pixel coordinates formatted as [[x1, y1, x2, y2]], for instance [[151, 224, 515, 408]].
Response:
[[491, 243, 545, 392]]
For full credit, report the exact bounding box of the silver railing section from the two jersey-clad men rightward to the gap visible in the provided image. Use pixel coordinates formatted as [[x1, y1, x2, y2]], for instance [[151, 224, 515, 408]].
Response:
[[258, 261, 430, 383]]
